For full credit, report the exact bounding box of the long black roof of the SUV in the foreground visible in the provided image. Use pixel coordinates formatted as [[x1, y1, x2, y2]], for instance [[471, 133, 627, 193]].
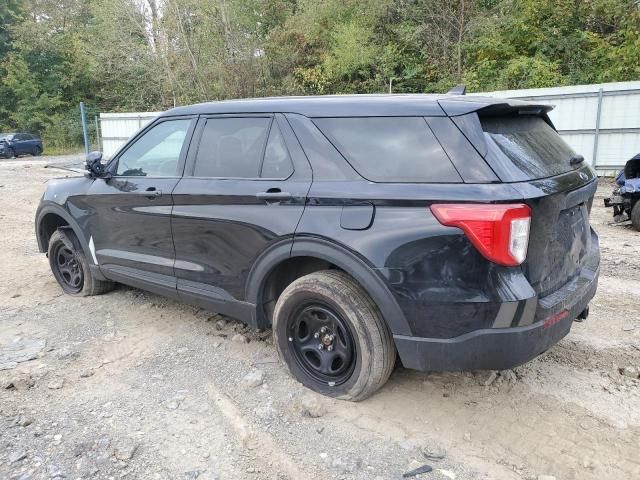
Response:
[[161, 94, 552, 117]]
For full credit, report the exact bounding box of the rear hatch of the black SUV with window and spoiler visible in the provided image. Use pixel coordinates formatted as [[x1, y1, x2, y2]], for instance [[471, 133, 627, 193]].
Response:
[[440, 97, 597, 297]]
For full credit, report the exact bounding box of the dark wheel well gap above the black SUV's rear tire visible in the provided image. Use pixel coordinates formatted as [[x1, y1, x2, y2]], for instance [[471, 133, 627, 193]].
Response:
[[260, 257, 341, 325]]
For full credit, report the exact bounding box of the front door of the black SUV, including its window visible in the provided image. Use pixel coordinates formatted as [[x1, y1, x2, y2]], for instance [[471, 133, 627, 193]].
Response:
[[77, 118, 195, 293]]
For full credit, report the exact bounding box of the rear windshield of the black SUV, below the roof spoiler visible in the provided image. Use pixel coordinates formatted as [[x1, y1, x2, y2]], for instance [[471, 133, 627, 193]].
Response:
[[480, 115, 575, 182]]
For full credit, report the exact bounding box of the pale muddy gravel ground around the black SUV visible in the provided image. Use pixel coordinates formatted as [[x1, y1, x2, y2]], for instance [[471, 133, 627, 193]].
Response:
[[0, 159, 640, 480]]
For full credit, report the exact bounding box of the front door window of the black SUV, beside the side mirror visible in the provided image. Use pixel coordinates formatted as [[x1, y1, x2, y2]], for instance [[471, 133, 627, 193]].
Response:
[[116, 119, 191, 177]]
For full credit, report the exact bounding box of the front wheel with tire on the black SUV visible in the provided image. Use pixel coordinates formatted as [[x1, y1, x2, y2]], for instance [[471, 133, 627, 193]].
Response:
[[48, 229, 114, 297]]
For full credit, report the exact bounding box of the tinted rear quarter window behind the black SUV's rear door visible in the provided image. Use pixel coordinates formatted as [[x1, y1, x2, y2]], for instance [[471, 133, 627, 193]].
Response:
[[313, 117, 462, 183]]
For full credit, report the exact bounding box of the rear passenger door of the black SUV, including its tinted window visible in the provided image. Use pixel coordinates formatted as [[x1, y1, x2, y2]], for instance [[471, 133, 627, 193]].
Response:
[[172, 115, 311, 321]]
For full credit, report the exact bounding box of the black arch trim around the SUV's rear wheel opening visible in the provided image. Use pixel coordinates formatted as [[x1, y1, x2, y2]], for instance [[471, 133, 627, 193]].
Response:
[[245, 238, 411, 335]]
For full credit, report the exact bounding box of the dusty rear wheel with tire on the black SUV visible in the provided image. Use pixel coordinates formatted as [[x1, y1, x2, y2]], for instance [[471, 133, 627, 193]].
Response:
[[273, 270, 396, 402]]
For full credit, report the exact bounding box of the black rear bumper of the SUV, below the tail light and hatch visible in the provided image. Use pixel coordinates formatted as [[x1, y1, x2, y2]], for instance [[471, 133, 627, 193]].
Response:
[[394, 262, 599, 371]]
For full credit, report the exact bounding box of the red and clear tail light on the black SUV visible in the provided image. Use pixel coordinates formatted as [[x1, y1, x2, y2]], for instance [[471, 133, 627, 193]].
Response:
[[431, 203, 531, 267]]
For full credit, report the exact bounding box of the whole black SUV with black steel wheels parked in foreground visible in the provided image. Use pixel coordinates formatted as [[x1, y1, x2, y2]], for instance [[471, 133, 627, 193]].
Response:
[[36, 95, 599, 400]]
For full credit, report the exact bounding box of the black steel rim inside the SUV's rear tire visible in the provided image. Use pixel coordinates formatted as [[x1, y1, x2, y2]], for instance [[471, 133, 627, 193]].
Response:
[[288, 303, 356, 385]]
